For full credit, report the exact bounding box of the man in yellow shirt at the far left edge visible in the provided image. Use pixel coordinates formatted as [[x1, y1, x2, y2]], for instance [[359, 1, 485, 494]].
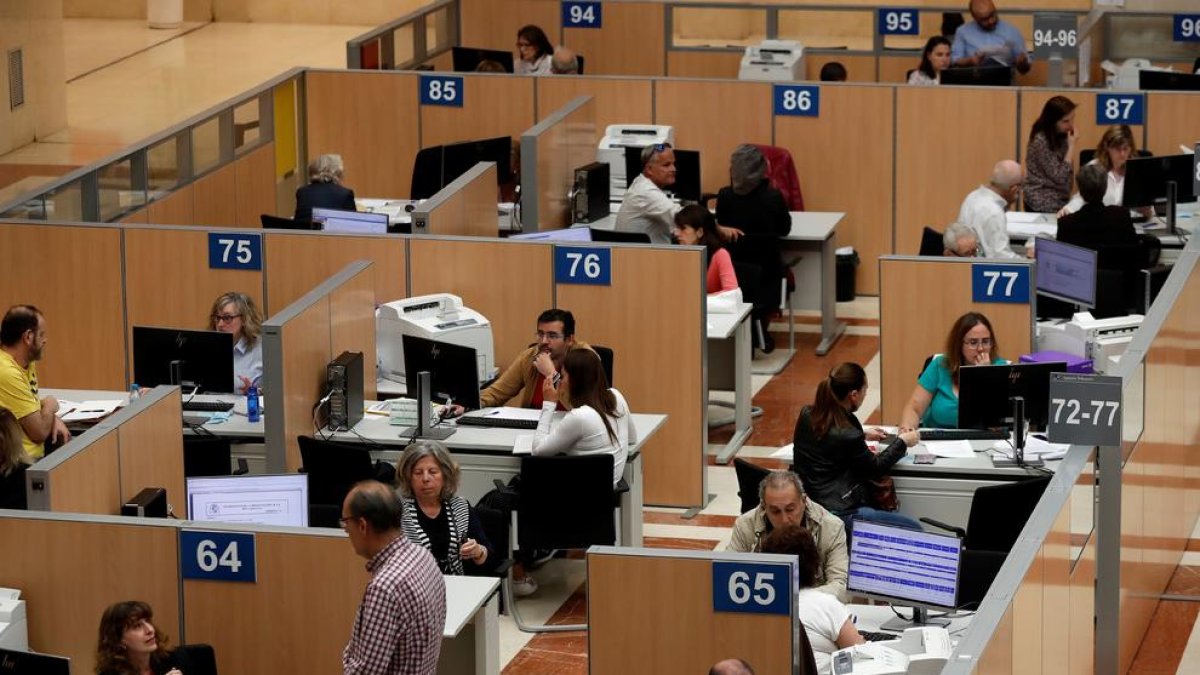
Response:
[[0, 305, 71, 460]]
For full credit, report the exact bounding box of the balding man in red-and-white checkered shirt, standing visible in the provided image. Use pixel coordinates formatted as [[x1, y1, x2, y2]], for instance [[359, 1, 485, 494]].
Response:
[[340, 480, 446, 675]]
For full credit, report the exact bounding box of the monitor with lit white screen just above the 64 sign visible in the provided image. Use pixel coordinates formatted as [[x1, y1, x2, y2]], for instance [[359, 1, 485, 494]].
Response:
[[187, 473, 308, 527]]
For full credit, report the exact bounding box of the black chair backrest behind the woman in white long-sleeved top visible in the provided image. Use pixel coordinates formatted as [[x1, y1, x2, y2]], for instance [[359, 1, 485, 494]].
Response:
[[517, 454, 617, 550]]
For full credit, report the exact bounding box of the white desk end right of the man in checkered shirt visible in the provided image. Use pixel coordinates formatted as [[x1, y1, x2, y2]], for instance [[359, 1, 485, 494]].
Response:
[[438, 577, 500, 675]]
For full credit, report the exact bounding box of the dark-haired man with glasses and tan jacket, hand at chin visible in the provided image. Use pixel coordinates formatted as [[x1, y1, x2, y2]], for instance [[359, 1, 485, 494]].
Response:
[[479, 310, 592, 410]]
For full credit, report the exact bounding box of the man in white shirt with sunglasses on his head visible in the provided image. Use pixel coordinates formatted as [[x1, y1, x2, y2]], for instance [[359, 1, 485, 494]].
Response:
[[617, 143, 683, 244]]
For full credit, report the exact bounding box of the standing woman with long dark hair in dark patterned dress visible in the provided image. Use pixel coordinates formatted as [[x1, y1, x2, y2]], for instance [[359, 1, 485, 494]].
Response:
[[1025, 96, 1076, 214]]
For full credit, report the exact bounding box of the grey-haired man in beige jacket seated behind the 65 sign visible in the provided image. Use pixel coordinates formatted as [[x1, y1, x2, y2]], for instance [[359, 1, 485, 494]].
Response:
[[726, 471, 850, 601]]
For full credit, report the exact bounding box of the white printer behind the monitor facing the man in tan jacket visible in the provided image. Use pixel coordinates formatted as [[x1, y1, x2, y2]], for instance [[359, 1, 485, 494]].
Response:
[[376, 293, 496, 383]]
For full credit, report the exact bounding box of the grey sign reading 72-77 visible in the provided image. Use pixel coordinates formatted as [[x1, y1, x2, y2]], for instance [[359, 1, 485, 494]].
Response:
[[1046, 372, 1121, 447]]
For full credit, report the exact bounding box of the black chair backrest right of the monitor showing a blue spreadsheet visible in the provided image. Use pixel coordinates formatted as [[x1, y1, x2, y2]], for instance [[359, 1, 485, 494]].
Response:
[[962, 476, 1050, 552]]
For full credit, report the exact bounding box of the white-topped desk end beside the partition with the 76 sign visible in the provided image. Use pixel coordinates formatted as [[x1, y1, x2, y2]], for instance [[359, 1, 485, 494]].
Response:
[[708, 303, 754, 464]]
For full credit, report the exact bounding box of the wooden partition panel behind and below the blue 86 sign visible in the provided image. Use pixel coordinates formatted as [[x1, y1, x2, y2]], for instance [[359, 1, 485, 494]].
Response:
[[775, 85, 895, 294]]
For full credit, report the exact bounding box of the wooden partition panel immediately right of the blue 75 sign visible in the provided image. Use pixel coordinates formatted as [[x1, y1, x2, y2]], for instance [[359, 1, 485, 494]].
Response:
[[264, 230, 403, 313]]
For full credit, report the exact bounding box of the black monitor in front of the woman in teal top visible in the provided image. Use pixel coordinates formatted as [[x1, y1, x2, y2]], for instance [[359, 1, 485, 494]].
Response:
[[959, 362, 1067, 429]]
